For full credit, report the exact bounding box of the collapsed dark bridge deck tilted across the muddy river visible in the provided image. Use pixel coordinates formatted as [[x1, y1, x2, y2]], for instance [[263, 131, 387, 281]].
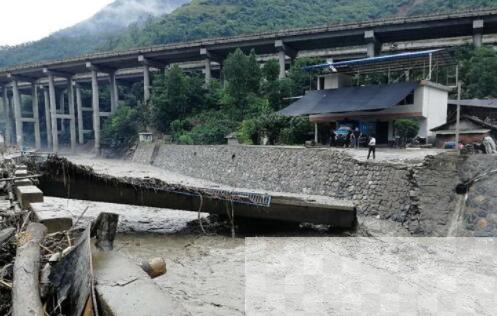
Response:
[[32, 156, 356, 228]]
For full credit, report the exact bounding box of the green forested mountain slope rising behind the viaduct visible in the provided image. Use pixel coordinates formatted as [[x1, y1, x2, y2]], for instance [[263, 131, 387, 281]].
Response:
[[0, 0, 497, 66]]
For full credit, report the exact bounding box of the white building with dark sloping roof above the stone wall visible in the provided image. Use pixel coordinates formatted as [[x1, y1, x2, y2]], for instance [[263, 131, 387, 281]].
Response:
[[279, 74, 450, 144]]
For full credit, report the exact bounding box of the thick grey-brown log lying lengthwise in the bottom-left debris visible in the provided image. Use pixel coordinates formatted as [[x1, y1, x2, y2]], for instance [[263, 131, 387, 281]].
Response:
[[12, 223, 47, 316]]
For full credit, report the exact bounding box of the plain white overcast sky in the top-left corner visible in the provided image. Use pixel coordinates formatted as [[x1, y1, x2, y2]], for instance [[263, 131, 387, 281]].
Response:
[[0, 0, 113, 46]]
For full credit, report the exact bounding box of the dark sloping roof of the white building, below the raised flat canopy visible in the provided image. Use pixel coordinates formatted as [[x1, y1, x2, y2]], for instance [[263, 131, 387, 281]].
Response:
[[278, 82, 419, 116]]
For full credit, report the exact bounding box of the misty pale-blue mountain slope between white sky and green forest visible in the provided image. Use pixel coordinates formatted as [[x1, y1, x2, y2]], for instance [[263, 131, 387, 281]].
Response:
[[53, 0, 190, 37]]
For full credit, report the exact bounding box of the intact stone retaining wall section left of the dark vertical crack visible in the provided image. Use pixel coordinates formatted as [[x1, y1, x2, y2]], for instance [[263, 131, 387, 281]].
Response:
[[139, 145, 411, 222]]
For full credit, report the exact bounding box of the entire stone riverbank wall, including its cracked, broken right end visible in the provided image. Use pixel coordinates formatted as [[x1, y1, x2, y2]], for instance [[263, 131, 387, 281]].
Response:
[[133, 144, 497, 236]]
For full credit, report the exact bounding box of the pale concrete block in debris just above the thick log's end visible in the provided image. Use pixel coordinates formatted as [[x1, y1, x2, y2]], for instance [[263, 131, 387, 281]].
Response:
[[31, 203, 73, 234]]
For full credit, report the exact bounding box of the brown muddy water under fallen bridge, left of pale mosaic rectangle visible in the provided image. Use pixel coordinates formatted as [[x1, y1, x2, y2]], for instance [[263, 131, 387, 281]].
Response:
[[36, 197, 245, 315]]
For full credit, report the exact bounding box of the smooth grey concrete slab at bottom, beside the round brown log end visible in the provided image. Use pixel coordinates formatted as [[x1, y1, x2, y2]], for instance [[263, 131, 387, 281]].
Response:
[[93, 250, 190, 316]]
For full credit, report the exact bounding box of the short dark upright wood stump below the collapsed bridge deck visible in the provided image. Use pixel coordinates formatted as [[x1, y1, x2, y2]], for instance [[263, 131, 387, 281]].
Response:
[[91, 213, 119, 251]]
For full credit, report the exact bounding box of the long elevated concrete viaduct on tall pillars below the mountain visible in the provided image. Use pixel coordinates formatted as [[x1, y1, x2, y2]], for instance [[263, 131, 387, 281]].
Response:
[[0, 9, 497, 153]]
